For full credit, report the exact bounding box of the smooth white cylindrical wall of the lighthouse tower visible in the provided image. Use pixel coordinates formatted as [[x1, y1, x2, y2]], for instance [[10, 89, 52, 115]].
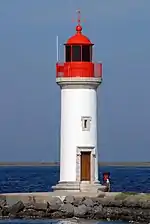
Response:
[[60, 88, 97, 181]]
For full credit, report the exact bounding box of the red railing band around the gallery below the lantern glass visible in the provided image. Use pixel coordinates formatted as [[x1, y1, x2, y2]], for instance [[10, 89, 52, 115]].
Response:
[[56, 62, 102, 78]]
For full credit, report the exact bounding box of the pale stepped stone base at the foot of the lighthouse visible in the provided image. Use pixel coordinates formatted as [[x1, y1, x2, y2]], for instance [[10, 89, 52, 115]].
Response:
[[52, 181, 106, 193]]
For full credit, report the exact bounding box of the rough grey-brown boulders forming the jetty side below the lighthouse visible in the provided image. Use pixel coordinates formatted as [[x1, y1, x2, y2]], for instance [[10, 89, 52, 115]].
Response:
[[0, 193, 150, 223]]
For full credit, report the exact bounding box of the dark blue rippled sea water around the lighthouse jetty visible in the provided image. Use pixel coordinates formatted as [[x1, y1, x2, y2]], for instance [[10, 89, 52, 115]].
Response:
[[0, 166, 150, 224]]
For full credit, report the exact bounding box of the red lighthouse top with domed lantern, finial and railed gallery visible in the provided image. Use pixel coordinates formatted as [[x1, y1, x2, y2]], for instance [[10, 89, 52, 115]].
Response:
[[56, 12, 102, 78]]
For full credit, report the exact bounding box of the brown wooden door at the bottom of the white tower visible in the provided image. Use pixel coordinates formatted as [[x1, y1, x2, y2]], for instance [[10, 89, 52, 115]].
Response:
[[81, 152, 91, 181]]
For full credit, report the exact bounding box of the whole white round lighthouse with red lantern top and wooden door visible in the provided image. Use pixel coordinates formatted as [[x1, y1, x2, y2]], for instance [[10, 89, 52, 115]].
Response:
[[52, 11, 105, 192]]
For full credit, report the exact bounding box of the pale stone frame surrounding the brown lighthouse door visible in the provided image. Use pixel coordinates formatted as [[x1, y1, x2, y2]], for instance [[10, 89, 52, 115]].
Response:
[[76, 146, 96, 183]]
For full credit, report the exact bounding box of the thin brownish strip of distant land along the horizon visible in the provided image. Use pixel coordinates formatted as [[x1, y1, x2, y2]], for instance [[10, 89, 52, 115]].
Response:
[[0, 162, 150, 167]]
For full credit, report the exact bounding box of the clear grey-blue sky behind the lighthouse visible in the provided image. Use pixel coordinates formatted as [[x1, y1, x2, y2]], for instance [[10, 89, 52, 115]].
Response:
[[0, 0, 150, 162]]
